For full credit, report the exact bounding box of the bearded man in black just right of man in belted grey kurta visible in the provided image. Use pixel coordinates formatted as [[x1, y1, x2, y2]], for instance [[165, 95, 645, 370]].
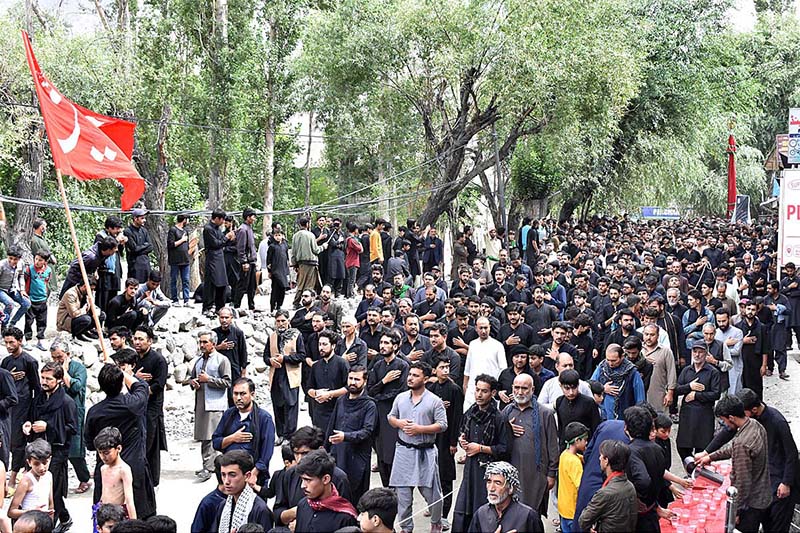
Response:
[[453, 374, 509, 531]]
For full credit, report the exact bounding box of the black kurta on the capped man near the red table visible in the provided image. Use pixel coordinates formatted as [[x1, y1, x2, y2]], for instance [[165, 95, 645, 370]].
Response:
[[675, 364, 720, 449]]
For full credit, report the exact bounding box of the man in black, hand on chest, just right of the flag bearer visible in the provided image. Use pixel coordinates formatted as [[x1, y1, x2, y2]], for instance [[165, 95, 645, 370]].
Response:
[[133, 327, 169, 487]]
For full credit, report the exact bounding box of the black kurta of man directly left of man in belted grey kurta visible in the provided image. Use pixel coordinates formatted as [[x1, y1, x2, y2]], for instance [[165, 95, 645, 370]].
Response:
[[367, 357, 408, 464]]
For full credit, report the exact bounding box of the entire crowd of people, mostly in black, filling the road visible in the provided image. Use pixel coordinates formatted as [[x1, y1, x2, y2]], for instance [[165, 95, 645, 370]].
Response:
[[0, 209, 800, 533]]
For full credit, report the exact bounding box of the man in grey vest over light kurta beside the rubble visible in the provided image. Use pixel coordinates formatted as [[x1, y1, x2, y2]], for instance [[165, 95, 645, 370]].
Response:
[[189, 330, 231, 481]]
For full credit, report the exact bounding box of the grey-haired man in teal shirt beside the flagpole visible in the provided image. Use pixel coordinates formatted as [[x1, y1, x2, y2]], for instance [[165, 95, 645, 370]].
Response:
[[50, 337, 90, 494]]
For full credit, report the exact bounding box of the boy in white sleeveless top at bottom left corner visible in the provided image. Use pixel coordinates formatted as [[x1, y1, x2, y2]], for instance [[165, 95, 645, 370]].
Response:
[[8, 439, 54, 520]]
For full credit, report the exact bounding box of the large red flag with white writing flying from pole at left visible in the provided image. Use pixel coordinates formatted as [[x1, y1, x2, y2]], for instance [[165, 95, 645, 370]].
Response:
[[22, 31, 144, 211]]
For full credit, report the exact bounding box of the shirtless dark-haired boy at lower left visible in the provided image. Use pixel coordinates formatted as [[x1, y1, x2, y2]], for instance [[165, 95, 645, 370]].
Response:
[[92, 427, 136, 528]]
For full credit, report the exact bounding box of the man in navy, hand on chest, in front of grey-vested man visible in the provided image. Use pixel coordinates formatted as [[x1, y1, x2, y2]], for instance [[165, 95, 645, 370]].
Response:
[[211, 378, 275, 486]]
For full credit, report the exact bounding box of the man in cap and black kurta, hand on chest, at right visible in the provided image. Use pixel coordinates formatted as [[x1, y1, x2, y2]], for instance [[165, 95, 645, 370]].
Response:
[[675, 340, 720, 459]]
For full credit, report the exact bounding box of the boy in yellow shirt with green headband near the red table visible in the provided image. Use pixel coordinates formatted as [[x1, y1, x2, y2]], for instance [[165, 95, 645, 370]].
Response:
[[558, 422, 589, 533]]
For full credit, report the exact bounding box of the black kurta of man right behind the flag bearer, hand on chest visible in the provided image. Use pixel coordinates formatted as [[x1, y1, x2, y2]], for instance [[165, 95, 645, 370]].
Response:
[[136, 348, 168, 487]]
